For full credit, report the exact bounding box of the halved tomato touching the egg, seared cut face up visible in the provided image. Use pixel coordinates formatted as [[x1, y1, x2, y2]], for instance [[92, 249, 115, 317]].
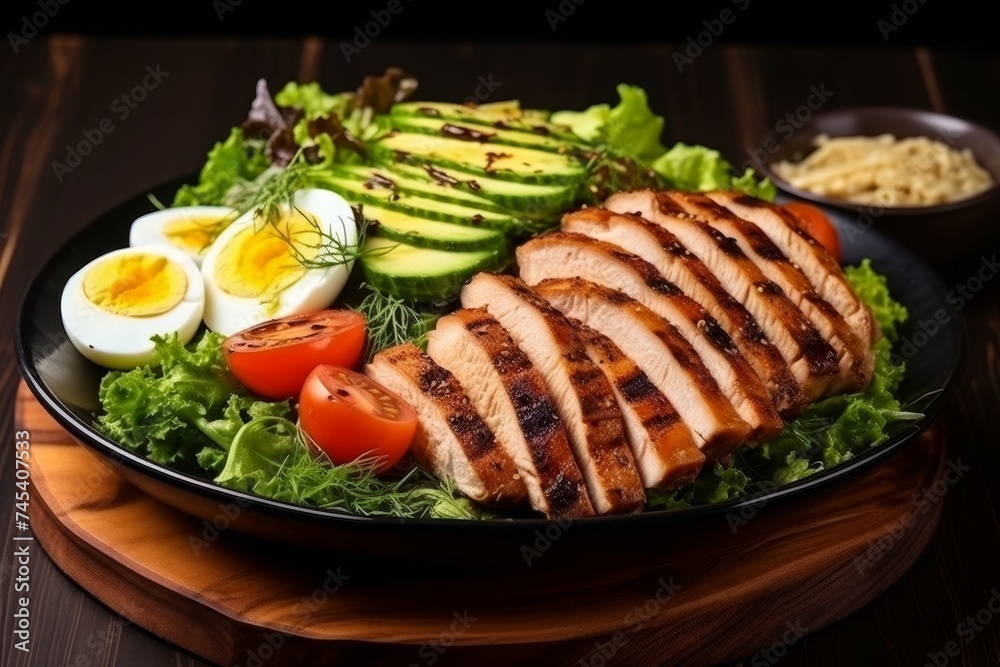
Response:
[[222, 310, 365, 400]]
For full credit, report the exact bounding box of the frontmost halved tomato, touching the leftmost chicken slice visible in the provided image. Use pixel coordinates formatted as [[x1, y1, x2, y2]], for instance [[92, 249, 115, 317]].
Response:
[[299, 365, 417, 472]]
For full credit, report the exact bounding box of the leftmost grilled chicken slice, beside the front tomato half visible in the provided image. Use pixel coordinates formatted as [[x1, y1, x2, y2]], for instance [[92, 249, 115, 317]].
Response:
[[365, 343, 527, 507]]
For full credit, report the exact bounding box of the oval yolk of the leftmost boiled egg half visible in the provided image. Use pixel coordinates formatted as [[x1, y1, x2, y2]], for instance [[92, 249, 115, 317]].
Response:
[[83, 253, 188, 317]]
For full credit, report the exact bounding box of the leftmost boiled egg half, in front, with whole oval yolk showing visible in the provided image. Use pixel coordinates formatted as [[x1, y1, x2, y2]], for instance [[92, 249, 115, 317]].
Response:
[[60, 245, 205, 370]]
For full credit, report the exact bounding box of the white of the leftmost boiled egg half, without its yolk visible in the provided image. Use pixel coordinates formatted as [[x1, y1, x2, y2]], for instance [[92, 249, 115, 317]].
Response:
[[60, 245, 205, 370]]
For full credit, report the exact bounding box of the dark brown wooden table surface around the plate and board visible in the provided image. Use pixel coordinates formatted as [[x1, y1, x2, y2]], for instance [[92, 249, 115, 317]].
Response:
[[0, 9, 1000, 666]]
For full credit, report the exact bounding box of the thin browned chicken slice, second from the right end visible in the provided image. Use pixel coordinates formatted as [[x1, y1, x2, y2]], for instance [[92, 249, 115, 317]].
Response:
[[670, 192, 874, 393]]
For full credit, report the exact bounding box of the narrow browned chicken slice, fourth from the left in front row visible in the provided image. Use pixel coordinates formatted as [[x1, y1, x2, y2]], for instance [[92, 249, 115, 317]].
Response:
[[572, 320, 705, 489]]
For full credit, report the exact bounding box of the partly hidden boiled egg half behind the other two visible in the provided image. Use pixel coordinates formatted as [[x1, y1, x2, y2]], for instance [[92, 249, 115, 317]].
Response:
[[128, 206, 239, 266]]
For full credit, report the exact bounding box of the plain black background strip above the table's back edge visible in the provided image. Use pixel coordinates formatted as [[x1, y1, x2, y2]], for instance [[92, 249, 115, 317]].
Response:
[[0, 0, 998, 48]]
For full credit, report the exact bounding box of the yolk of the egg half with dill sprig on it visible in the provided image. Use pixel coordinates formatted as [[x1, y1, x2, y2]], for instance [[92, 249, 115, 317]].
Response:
[[214, 212, 321, 301]]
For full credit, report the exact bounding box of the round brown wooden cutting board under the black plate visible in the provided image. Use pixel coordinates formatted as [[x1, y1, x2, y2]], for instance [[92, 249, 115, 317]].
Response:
[[16, 384, 946, 667]]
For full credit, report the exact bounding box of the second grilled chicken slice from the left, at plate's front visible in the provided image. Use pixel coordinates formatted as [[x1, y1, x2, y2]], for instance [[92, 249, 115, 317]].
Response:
[[427, 309, 594, 518]]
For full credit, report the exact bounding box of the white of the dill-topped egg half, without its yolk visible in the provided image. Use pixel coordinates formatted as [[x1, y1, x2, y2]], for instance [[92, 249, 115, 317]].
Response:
[[201, 189, 358, 336]]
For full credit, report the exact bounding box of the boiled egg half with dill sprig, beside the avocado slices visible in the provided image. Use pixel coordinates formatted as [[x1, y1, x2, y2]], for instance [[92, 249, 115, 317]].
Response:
[[201, 189, 358, 336]]
